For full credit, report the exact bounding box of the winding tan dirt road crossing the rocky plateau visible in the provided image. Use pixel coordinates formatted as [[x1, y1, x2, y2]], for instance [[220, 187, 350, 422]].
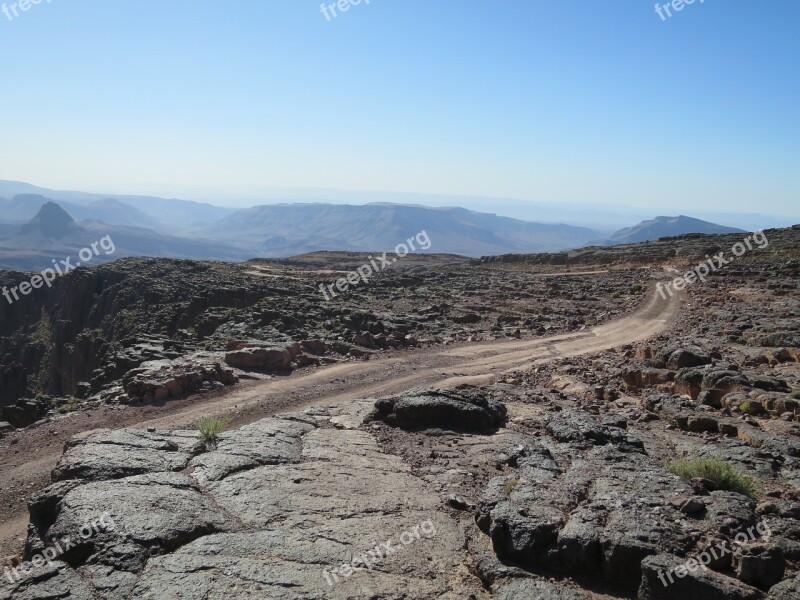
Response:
[[0, 284, 681, 560]]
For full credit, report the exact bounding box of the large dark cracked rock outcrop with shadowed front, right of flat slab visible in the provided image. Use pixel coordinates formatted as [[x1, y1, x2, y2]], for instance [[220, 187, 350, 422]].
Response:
[[476, 441, 694, 588]]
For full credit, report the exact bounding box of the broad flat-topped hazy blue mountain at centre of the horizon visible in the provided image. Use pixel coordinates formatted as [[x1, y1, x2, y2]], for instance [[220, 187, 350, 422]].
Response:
[[198, 204, 597, 257]]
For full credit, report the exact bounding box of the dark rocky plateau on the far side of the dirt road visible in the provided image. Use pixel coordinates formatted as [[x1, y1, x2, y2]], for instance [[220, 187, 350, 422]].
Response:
[[0, 254, 642, 427]]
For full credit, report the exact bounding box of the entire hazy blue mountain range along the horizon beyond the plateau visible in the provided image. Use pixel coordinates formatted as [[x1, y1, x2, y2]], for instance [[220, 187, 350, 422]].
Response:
[[0, 181, 768, 270]]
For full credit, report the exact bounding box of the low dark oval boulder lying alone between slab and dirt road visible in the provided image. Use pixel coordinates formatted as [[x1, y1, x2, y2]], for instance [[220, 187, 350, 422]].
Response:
[[372, 390, 506, 431]]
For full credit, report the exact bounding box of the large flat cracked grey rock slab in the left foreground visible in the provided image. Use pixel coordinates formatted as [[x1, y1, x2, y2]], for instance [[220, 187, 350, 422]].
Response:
[[0, 402, 476, 600]]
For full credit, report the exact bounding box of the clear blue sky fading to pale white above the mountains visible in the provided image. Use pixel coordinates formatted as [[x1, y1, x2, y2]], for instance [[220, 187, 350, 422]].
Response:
[[0, 0, 800, 215]]
